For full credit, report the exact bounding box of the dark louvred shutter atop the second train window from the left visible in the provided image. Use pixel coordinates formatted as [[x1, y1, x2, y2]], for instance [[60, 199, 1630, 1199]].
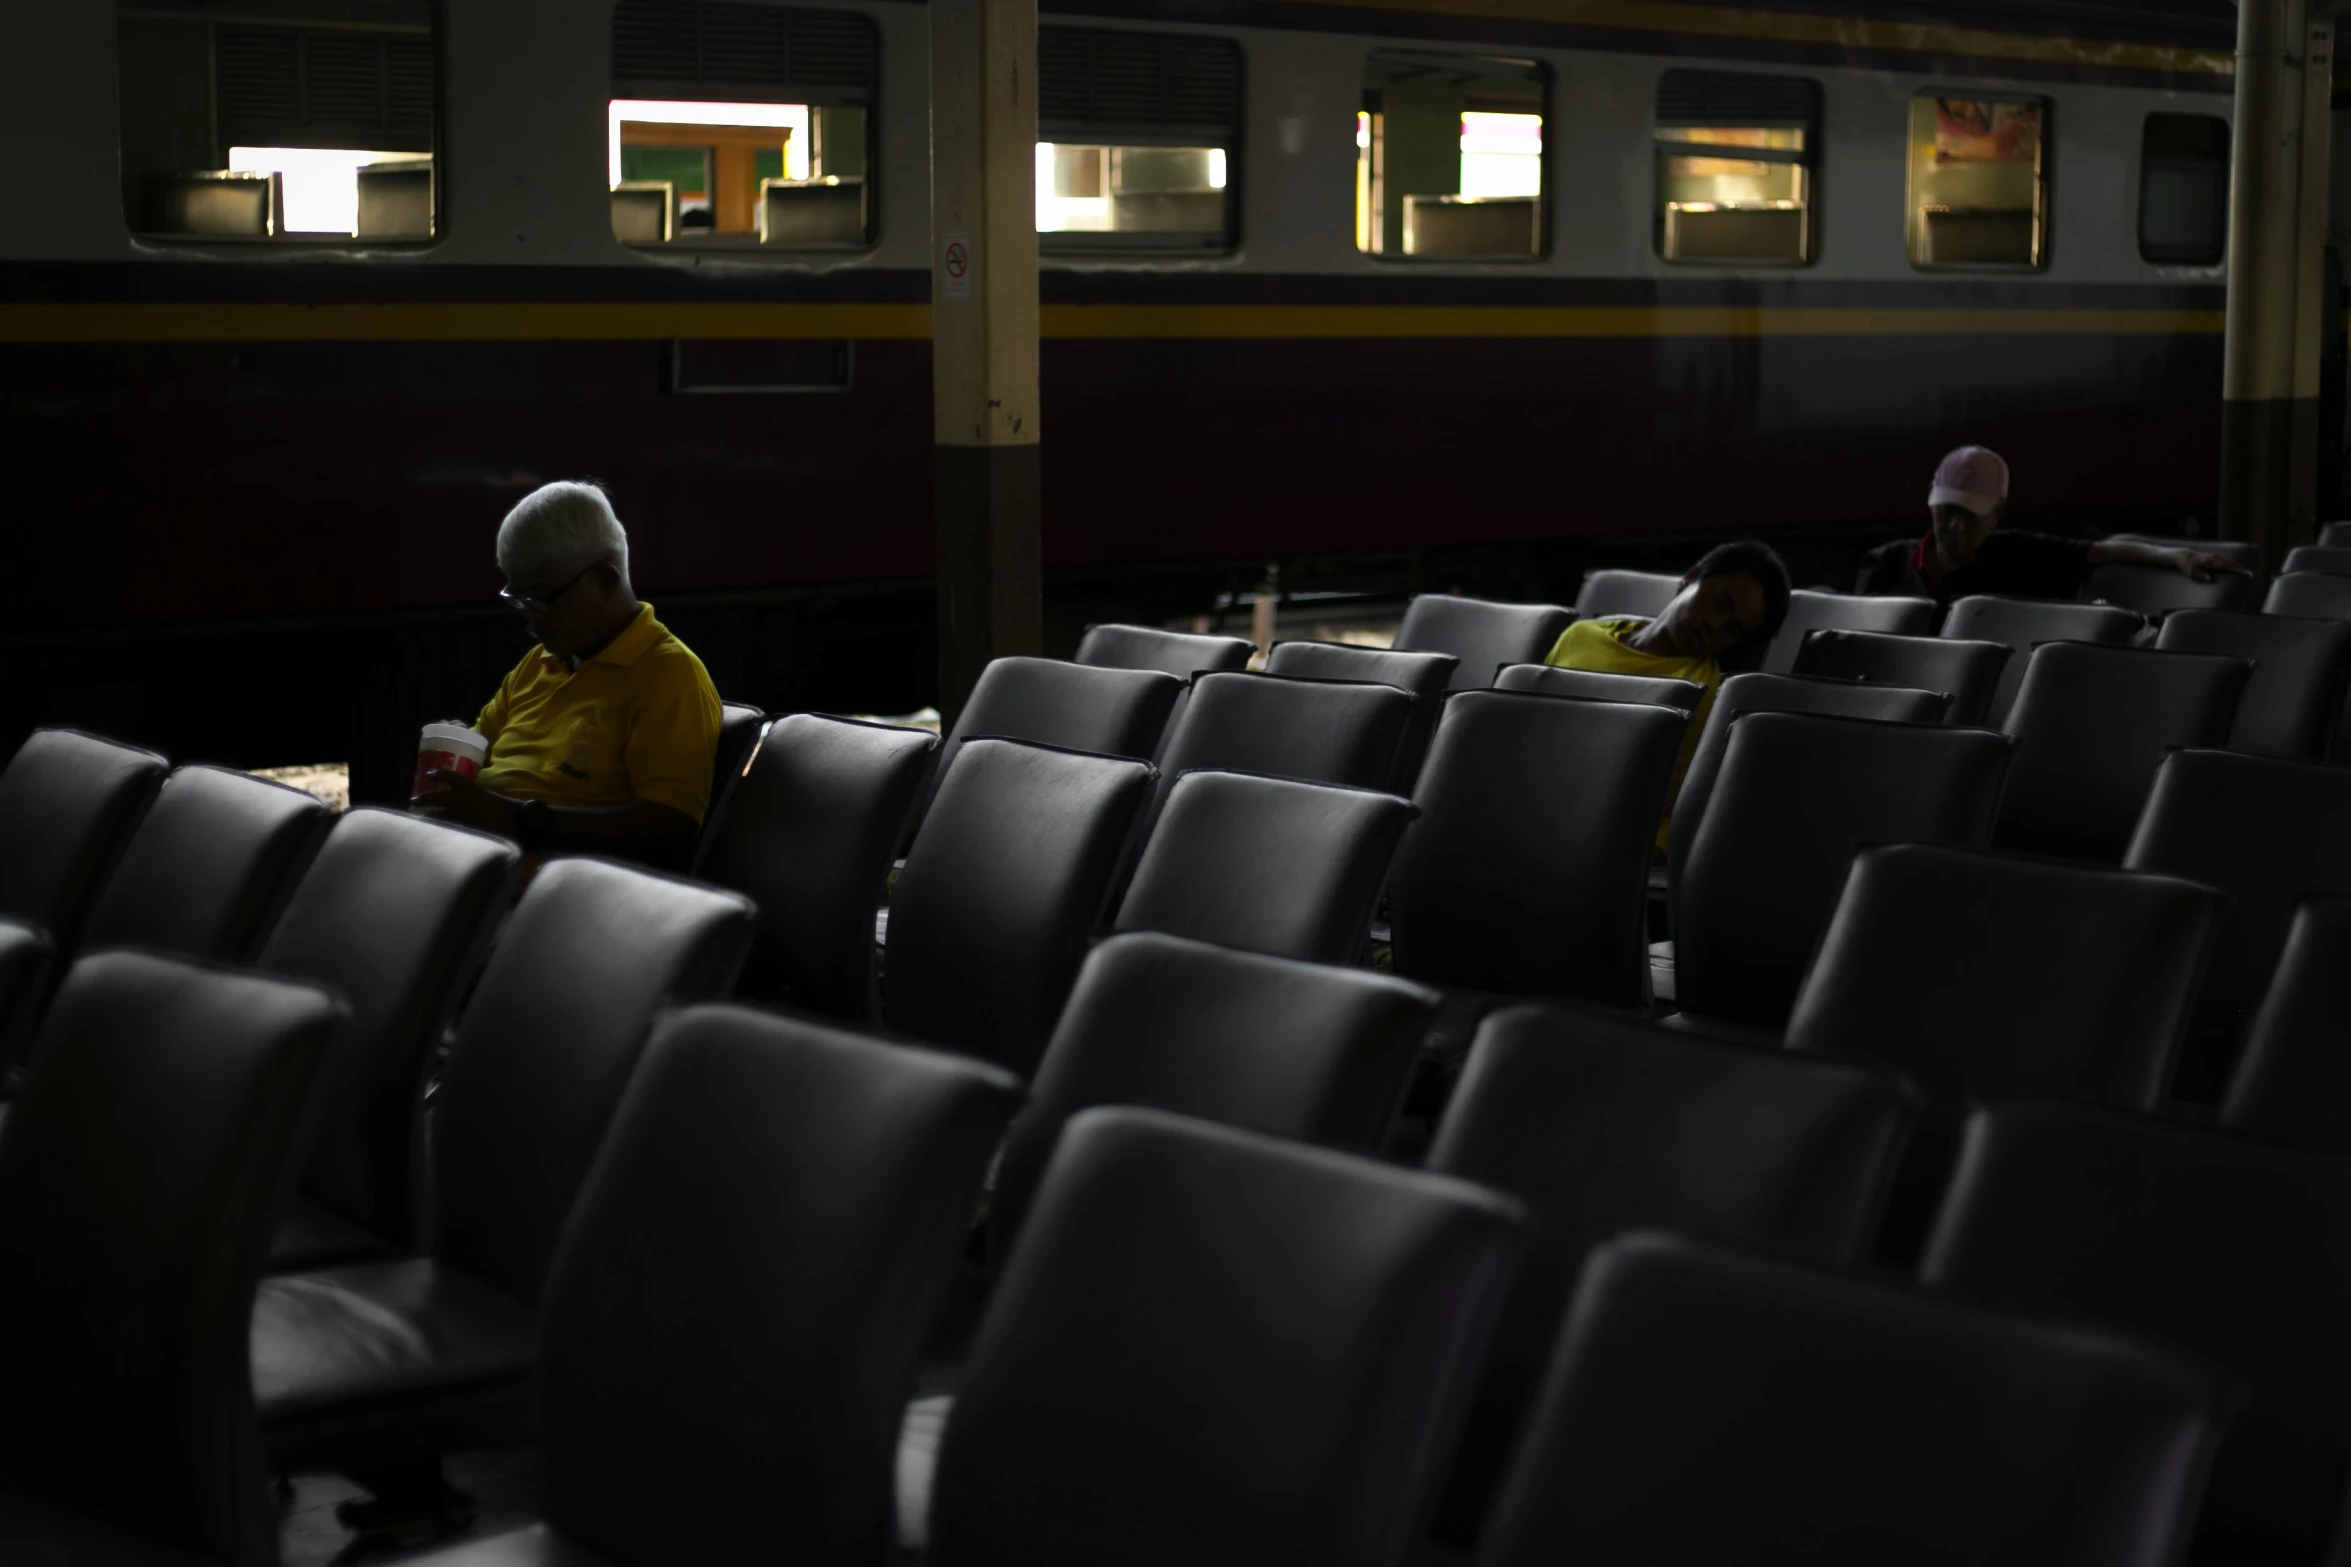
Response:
[[611, 0, 877, 103]]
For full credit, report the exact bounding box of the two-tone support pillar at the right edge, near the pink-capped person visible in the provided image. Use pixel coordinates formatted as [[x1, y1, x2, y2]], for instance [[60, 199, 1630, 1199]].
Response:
[[2219, 0, 2335, 566]]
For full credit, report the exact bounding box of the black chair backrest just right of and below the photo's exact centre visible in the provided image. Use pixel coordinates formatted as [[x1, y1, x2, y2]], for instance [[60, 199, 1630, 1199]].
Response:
[[1114, 773, 1415, 963]]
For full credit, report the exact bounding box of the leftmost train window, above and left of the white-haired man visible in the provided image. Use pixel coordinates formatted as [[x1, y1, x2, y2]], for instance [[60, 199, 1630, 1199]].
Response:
[[115, 0, 440, 244]]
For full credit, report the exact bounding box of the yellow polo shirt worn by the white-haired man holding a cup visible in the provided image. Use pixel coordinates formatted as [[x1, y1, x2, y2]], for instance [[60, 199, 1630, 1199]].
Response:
[[473, 604, 719, 822]]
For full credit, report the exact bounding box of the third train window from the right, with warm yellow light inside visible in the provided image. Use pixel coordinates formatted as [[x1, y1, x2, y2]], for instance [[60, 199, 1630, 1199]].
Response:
[[1657, 70, 1820, 265]]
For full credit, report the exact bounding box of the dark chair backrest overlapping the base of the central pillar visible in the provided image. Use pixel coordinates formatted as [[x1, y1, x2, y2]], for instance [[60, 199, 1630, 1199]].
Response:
[[915, 658, 1185, 820]]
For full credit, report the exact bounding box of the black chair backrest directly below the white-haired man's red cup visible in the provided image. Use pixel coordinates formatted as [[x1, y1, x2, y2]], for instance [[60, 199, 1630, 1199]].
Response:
[[254, 806, 522, 1245]]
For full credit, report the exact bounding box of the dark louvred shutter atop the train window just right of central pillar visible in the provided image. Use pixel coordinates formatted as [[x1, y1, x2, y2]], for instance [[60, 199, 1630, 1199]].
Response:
[[1037, 28, 1241, 141]]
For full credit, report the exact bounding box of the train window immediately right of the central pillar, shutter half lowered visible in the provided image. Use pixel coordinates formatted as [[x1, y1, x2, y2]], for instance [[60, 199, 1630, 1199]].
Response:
[[1037, 26, 1241, 251]]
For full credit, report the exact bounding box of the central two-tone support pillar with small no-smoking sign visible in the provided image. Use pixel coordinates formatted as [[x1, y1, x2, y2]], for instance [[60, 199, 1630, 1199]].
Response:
[[926, 0, 1044, 721]]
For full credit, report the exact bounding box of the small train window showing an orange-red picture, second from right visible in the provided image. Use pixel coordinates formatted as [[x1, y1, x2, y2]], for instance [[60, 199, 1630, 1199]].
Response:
[[1909, 92, 2050, 270]]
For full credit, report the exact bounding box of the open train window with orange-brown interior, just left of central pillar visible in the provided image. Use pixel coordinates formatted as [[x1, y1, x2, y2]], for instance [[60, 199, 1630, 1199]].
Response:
[[607, 0, 879, 249]]
